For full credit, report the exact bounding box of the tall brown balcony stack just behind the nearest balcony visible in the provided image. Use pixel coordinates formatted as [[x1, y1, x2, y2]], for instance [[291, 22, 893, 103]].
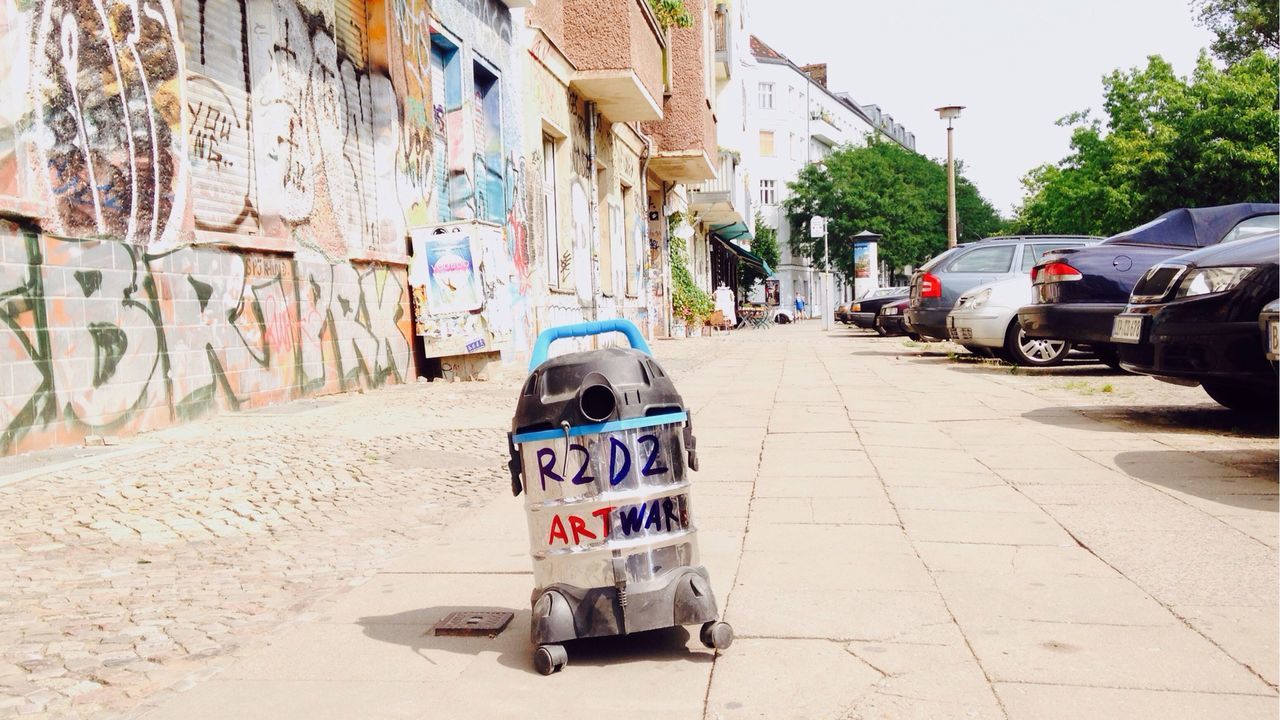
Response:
[[643, 0, 718, 183]]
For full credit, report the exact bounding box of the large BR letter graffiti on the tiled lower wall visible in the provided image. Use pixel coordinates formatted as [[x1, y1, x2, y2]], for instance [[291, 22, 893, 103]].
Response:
[[0, 222, 412, 454]]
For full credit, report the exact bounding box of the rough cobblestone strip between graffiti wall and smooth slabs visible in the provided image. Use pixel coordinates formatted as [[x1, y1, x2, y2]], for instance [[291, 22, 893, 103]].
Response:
[[0, 375, 517, 716]]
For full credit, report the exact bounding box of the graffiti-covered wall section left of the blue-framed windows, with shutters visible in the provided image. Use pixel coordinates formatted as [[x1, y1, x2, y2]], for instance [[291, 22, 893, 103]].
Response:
[[0, 0, 433, 452]]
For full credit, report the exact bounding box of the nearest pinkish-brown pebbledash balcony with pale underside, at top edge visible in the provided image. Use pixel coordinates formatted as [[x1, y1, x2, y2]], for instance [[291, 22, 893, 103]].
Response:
[[560, 0, 666, 122]]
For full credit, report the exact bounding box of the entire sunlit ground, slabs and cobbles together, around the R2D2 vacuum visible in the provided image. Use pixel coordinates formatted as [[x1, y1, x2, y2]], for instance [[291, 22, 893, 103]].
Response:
[[0, 322, 1280, 720]]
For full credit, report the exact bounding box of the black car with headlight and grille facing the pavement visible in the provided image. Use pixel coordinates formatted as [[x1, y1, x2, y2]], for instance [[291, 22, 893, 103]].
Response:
[[1110, 233, 1280, 413]]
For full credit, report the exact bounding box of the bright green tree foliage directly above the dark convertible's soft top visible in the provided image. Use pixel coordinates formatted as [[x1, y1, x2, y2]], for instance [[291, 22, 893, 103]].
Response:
[[1011, 53, 1280, 234]]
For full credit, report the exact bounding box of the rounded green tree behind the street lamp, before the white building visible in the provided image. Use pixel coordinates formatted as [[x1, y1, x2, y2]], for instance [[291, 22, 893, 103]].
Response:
[[786, 138, 1001, 282]]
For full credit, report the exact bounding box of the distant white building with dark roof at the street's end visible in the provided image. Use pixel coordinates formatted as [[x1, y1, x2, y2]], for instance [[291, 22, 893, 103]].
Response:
[[742, 35, 915, 316]]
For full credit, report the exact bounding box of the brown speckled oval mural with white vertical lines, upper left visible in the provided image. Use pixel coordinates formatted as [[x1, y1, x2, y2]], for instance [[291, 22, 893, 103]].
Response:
[[29, 0, 187, 245]]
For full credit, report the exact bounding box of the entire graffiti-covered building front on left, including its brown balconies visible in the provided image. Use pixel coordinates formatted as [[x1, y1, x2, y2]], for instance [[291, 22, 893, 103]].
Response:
[[0, 0, 716, 452]]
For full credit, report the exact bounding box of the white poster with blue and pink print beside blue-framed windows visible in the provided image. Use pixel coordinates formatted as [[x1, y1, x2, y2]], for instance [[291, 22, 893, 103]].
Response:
[[408, 229, 484, 315]]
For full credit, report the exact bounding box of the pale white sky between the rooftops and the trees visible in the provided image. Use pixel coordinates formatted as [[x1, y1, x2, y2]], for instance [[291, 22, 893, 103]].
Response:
[[748, 0, 1212, 217]]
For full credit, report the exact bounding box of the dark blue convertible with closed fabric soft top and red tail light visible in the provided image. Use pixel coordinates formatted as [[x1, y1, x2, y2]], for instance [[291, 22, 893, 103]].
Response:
[[1018, 202, 1280, 365]]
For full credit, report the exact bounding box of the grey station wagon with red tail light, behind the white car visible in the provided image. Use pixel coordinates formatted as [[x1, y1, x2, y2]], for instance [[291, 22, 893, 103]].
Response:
[[906, 236, 1101, 340]]
